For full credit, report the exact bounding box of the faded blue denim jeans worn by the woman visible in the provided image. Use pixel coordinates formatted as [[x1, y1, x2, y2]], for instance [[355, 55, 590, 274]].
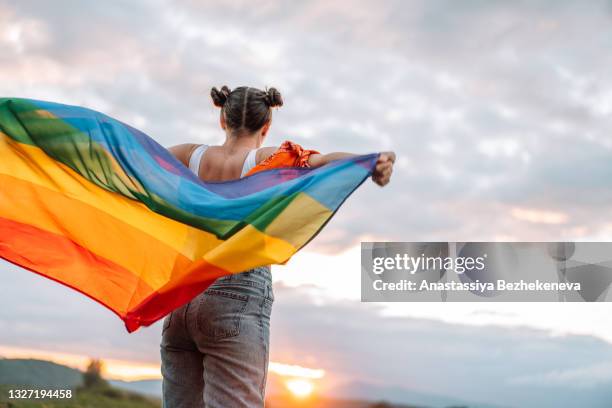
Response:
[[161, 266, 274, 408]]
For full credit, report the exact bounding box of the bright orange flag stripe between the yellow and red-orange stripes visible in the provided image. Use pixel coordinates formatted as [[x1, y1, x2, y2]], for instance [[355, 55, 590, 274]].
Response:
[[0, 174, 190, 289]]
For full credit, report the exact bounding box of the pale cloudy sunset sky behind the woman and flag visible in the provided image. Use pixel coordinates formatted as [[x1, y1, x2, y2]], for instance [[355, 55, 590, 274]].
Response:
[[0, 0, 612, 406]]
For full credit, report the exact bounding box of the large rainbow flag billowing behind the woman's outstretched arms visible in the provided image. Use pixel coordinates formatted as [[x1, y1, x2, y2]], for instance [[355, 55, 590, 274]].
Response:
[[0, 98, 378, 332]]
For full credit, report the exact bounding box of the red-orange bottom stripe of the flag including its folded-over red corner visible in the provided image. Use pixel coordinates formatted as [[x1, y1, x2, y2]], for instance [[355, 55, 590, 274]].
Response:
[[0, 217, 237, 333]]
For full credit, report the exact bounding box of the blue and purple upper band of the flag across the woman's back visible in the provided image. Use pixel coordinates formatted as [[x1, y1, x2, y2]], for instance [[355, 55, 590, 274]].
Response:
[[30, 100, 377, 220]]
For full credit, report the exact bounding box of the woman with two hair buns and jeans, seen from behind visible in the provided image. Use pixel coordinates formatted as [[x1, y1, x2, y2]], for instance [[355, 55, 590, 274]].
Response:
[[161, 86, 395, 408]]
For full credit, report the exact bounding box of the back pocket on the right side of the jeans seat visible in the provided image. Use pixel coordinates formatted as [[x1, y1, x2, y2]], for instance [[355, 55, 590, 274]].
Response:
[[197, 289, 249, 340]]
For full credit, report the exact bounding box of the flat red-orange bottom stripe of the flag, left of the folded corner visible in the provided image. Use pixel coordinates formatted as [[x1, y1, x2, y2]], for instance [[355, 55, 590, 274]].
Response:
[[0, 217, 154, 319]]
